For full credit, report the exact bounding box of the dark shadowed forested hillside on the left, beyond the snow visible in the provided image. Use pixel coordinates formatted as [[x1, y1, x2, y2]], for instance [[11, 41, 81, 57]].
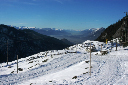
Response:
[[0, 24, 69, 63]]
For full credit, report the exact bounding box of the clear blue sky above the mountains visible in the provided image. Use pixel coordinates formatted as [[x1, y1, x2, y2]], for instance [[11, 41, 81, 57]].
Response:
[[0, 0, 128, 30]]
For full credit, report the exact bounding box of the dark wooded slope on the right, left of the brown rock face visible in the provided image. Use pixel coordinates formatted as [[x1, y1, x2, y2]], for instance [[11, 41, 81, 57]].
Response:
[[96, 17, 124, 42]]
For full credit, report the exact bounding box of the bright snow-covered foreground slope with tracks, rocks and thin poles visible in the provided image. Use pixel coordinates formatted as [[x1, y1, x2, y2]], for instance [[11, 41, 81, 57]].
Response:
[[0, 41, 128, 85]]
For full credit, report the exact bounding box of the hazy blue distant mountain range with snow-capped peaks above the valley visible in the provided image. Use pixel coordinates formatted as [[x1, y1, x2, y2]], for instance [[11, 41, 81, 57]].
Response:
[[10, 26, 105, 44]]
